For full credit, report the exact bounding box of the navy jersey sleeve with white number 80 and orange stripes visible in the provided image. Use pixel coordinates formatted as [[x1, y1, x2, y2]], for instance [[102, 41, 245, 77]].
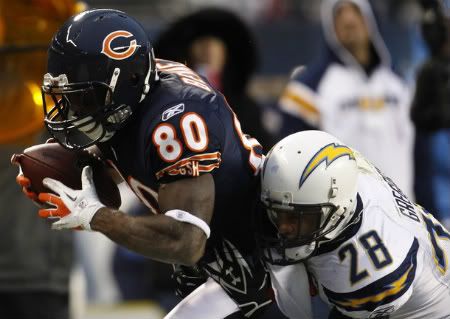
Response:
[[149, 100, 224, 183]]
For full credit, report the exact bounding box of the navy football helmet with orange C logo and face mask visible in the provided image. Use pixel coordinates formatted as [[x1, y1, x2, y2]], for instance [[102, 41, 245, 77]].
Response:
[[42, 9, 157, 149]]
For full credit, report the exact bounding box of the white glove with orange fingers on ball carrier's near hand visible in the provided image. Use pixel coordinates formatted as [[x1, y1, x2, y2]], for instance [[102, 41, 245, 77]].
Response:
[[38, 166, 105, 230]]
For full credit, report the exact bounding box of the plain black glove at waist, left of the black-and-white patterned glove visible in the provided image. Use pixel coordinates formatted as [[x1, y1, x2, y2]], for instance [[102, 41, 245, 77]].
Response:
[[172, 265, 208, 298]]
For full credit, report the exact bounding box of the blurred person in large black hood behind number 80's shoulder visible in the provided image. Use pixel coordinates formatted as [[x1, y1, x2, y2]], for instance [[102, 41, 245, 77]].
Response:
[[155, 8, 273, 149]]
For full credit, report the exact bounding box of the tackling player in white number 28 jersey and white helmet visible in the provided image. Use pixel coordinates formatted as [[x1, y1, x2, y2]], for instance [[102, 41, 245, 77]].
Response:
[[261, 131, 450, 319]]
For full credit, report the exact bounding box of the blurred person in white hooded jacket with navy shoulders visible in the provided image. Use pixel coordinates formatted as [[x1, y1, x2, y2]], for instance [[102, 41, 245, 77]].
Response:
[[279, 0, 412, 195]]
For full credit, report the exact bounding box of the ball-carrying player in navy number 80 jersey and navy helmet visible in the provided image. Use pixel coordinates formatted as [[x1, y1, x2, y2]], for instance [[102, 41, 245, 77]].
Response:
[[15, 9, 271, 318]]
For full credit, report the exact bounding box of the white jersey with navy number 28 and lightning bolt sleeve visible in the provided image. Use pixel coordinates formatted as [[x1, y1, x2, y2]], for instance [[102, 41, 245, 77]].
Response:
[[271, 162, 450, 319]]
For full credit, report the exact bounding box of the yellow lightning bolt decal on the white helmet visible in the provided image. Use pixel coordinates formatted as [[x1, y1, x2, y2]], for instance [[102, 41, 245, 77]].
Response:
[[299, 143, 355, 187]]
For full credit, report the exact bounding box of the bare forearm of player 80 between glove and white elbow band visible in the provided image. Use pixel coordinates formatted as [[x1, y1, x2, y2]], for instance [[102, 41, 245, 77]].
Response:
[[91, 208, 204, 265]]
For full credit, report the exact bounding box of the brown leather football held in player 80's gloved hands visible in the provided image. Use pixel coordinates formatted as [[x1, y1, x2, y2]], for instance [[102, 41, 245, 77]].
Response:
[[11, 143, 121, 209]]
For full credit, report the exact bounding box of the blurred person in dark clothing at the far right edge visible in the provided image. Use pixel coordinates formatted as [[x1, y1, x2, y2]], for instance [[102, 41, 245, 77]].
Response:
[[411, 0, 450, 228]]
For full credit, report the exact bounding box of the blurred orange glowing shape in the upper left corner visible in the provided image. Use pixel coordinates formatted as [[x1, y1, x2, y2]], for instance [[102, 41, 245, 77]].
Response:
[[0, 0, 87, 144]]
